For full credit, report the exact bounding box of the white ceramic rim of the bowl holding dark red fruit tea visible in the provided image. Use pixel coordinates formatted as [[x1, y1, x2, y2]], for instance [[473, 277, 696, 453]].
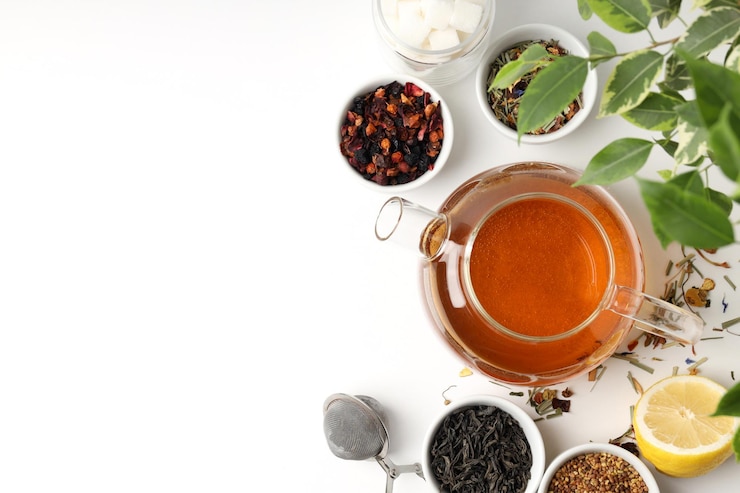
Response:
[[336, 74, 455, 194]]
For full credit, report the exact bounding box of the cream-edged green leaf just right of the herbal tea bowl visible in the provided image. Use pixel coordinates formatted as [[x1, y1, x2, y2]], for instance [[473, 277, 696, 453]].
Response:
[[599, 50, 663, 117]]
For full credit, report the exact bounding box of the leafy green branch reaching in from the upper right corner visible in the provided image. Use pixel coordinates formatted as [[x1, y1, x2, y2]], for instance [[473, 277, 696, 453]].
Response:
[[493, 0, 740, 249]]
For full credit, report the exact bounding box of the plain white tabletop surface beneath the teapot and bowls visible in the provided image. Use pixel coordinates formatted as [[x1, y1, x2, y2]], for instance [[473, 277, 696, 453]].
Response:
[[0, 0, 740, 493]]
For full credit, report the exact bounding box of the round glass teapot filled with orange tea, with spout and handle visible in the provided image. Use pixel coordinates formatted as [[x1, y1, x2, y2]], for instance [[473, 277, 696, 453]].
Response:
[[375, 162, 704, 386]]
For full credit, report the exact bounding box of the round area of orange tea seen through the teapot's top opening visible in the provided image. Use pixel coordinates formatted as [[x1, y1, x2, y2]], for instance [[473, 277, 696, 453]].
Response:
[[468, 196, 611, 337]]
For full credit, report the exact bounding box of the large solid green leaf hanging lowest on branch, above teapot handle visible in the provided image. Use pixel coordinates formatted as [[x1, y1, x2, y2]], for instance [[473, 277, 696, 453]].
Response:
[[637, 178, 735, 249]]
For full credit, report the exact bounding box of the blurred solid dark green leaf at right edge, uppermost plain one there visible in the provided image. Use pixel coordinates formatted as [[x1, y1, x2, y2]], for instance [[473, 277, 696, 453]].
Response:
[[682, 54, 740, 128]]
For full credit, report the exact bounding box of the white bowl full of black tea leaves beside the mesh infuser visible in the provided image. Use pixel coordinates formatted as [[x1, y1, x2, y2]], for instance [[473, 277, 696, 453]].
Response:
[[422, 395, 545, 493]]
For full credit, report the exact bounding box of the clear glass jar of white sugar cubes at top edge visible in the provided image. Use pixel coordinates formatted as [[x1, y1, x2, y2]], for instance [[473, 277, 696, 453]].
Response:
[[373, 0, 495, 86]]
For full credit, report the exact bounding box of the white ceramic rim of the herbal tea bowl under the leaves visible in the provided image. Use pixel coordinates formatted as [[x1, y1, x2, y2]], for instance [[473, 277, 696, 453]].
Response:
[[475, 24, 598, 144]]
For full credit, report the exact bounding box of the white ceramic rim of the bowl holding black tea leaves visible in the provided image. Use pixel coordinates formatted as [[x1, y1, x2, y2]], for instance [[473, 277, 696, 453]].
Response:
[[421, 394, 545, 493]]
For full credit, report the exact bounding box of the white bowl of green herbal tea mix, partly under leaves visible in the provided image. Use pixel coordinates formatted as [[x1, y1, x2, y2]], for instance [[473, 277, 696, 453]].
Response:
[[475, 24, 598, 144]]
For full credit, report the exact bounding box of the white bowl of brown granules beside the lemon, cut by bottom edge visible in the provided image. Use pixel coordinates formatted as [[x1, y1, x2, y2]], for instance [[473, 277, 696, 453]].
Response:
[[537, 443, 659, 493]]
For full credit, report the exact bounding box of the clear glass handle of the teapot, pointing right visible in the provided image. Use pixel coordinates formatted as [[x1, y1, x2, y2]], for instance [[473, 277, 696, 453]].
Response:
[[609, 286, 704, 344]]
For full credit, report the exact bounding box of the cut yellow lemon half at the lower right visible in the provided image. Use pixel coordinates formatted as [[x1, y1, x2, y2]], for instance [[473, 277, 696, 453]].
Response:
[[632, 375, 737, 478]]
